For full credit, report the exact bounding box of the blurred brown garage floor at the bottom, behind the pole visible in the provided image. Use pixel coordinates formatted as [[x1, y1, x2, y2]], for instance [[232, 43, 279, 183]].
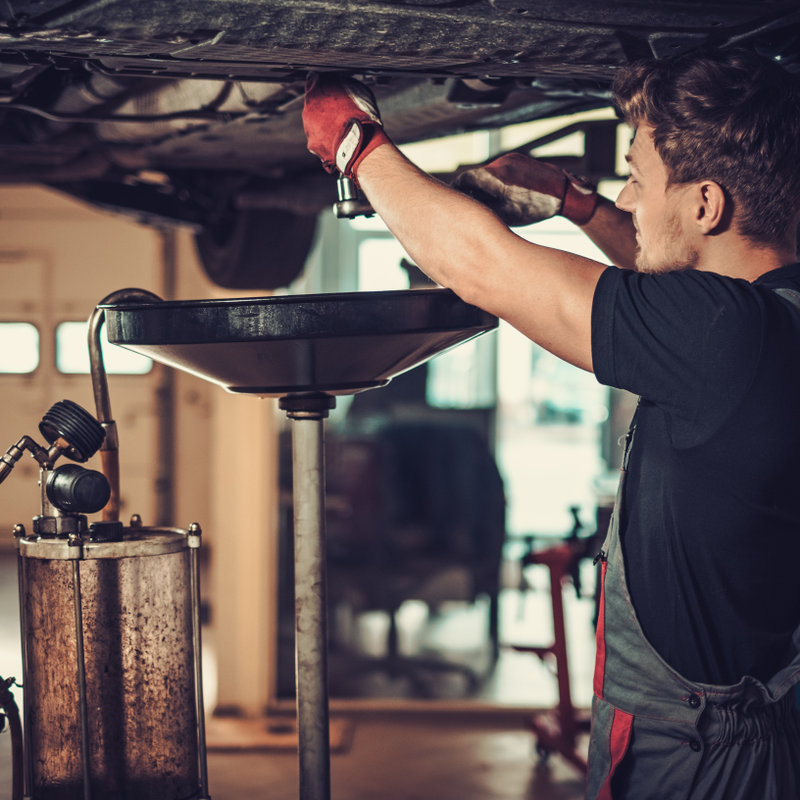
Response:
[[0, 713, 583, 800]]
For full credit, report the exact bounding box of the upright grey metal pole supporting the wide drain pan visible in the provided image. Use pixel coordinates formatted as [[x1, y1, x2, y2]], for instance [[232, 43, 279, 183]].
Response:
[[281, 395, 335, 800]]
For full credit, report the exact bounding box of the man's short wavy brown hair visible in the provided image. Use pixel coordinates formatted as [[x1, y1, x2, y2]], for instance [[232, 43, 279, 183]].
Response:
[[613, 49, 800, 245]]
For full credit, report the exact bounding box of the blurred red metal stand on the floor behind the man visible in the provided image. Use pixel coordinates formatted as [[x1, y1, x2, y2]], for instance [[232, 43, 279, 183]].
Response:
[[512, 540, 589, 773]]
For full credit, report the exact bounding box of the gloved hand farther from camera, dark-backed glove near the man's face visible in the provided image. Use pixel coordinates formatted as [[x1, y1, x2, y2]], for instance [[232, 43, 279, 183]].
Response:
[[453, 153, 599, 225]]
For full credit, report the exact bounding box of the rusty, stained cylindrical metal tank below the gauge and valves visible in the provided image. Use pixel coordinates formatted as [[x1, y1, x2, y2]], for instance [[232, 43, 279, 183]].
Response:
[[18, 527, 202, 800]]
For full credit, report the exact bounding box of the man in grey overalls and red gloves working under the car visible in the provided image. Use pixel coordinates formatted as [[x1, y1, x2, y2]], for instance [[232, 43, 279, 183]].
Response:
[[303, 50, 800, 800]]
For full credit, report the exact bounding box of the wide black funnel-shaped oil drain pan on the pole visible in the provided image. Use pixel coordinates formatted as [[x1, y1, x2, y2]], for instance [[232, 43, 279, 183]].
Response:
[[104, 289, 497, 397]]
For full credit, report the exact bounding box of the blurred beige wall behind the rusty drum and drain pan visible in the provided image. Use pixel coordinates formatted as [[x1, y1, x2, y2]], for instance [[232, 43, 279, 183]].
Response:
[[0, 186, 277, 714]]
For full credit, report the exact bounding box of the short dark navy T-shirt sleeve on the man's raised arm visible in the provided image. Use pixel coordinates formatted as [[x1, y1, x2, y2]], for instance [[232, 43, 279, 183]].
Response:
[[592, 267, 765, 445]]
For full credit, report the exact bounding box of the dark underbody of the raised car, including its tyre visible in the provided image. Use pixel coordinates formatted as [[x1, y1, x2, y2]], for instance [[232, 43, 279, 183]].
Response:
[[0, 0, 800, 288]]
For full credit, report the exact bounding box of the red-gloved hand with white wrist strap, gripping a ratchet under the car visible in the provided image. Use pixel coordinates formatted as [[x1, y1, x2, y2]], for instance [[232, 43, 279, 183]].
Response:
[[303, 73, 391, 180]]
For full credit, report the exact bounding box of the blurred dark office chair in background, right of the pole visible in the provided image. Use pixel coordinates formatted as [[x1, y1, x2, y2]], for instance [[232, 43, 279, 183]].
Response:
[[326, 419, 505, 691]]
